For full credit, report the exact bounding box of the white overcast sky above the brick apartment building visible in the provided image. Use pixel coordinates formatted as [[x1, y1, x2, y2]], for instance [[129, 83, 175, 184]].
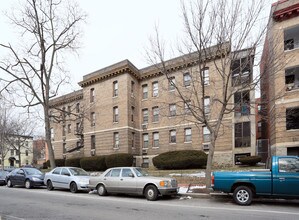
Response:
[[0, 0, 274, 93]]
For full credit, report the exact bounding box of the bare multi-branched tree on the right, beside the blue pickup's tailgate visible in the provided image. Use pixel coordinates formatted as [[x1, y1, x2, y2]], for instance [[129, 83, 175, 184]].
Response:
[[147, 0, 266, 188]]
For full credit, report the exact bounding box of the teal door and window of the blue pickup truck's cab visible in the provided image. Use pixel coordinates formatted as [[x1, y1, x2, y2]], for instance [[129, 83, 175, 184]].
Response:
[[273, 157, 299, 196]]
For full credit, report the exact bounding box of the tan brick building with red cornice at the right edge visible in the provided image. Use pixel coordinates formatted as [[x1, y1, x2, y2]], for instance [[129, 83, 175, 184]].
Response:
[[260, 0, 299, 155]]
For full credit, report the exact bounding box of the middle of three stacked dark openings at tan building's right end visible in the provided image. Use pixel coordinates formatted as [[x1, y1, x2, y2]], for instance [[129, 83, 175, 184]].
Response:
[[234, 91, 250, 116]]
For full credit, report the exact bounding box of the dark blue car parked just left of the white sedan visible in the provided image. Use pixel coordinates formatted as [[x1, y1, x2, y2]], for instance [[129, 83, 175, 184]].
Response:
[[6, 168, 44, 189]]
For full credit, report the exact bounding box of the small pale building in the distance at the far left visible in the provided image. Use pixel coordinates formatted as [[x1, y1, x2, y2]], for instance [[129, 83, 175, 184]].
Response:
[[0, 135, 33, 167]]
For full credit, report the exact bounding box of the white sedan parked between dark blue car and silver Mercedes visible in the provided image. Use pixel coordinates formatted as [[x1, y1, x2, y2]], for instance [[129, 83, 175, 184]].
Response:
[[44, 167, 90, 193]]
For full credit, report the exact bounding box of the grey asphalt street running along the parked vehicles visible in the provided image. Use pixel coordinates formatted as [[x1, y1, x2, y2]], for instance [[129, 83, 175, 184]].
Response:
[[0, 186, 299, 220]]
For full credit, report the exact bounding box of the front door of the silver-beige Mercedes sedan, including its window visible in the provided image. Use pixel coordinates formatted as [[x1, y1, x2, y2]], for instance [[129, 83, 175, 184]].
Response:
[[118, 168, 137, 194]]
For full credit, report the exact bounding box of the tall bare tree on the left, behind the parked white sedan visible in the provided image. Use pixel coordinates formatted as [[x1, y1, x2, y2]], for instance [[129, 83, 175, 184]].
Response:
[[0, 0, 86, 168]]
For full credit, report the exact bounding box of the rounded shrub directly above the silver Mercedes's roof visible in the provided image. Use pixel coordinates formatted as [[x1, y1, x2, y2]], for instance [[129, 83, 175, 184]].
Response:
[[105, 153, 133, 168]]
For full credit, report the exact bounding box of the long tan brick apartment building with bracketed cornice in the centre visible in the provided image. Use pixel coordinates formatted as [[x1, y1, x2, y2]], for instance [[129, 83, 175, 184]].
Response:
[[50, 45, 256, 166]]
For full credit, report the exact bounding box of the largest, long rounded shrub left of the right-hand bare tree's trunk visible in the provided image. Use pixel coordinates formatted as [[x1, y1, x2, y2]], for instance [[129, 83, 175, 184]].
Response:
[[153, 150, 207, 170]]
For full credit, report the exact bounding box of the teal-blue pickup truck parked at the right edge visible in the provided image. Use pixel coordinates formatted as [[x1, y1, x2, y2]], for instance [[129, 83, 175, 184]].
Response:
[[212, 156, 299, 205]]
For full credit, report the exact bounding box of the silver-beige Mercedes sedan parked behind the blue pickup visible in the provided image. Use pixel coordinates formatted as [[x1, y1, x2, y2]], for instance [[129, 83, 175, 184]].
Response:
[[88, 167, 178, 201]]
